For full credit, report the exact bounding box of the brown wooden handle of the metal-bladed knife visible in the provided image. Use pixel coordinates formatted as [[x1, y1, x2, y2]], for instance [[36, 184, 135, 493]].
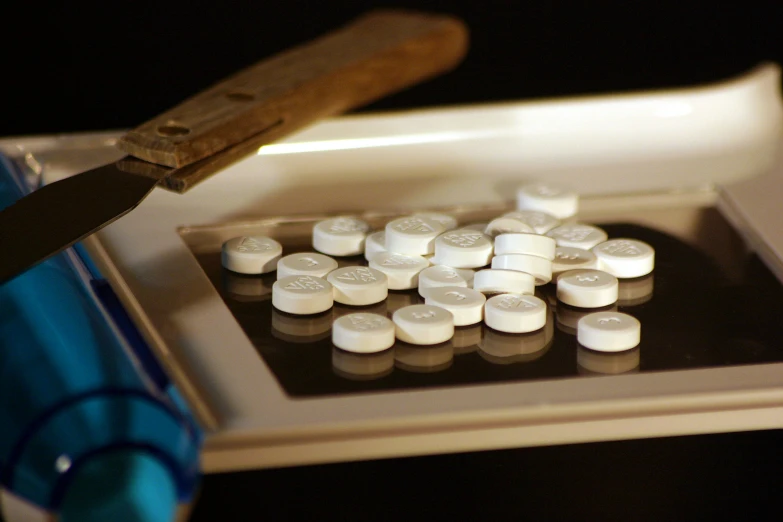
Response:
[[118, 11, 467, 171]]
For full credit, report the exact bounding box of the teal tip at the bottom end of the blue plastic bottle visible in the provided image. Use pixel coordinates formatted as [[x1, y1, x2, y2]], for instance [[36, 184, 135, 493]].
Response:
[[59, 450, 177, 522]]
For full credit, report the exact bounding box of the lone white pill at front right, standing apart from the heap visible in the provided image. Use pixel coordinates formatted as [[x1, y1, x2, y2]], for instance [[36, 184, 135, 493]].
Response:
[[576, 312, 642, 352]]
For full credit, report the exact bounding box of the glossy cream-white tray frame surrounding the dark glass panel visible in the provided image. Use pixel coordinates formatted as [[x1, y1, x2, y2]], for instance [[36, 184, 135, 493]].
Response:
[[7, 61, 783, 472]]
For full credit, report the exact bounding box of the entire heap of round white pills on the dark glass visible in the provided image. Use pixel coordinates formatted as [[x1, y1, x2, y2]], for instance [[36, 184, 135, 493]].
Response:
[[222, 183, 655, 353]]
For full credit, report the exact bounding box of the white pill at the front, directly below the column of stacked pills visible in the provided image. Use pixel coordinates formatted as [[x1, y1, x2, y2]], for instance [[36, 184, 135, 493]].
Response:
[[484, 294, 548, 333]]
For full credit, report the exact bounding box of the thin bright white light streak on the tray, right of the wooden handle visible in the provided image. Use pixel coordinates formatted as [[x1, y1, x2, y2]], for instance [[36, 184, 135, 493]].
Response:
[[258, 130, 508, 156]]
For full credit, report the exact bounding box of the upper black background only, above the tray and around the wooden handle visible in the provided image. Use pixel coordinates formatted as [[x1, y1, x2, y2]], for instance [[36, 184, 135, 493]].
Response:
[[0, 0, 783, 136]]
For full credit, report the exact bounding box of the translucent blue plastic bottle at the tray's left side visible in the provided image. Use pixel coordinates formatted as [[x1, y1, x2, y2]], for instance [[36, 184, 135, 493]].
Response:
[[0, 158, 202, 522]]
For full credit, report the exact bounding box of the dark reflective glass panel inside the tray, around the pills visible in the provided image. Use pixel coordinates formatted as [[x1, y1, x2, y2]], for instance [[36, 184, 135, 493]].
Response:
[[196, 218, 783, 398]]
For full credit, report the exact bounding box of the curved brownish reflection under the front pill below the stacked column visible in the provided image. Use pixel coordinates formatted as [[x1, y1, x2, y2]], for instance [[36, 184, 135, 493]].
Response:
[[479, 318, 555, 364]]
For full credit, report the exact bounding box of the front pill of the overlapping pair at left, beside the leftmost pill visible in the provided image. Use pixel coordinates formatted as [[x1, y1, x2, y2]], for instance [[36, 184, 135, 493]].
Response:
[[272, 276, 334, 315]]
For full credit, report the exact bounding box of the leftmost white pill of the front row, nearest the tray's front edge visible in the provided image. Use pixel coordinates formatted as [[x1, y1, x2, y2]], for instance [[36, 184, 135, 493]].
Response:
[[332, 313, 394, 353]]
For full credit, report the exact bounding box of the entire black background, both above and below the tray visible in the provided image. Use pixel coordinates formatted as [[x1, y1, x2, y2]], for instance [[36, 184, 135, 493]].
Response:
[[0, 0, 783, 522]]
